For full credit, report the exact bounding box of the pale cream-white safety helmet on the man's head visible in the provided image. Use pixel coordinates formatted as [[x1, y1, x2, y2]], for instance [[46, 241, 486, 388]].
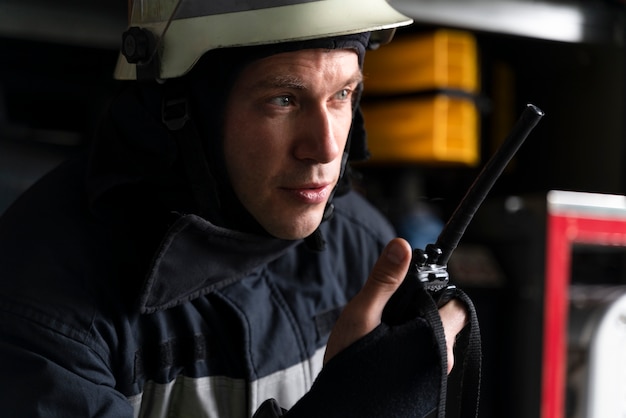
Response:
[[115, 0, 412, 80]]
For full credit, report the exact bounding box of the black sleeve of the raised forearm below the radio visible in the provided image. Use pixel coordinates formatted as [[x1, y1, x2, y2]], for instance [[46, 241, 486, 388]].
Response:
[[254, 318, 441, 418]]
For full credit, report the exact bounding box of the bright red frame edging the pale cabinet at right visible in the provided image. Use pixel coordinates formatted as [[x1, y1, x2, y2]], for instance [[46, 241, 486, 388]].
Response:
[[541, 198, 626, 418]]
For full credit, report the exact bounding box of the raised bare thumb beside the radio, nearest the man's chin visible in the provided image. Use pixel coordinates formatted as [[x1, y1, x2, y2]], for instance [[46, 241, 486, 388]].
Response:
[[324, 238, 412, 362]]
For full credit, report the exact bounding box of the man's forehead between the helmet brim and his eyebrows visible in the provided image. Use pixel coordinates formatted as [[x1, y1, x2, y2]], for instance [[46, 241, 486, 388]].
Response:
[[238, 49, 361, 88]]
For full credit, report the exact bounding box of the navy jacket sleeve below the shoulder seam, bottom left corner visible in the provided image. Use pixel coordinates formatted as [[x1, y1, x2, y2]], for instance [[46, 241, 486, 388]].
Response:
[[0, 301, 133, 418]]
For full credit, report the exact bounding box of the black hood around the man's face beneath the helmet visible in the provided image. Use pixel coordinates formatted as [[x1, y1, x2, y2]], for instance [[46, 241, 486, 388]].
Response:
[[88, 34, 369, 247]]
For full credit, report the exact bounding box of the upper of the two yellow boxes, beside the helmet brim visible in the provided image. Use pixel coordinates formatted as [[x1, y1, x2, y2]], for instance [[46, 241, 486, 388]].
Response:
[[363, 29, 480, 95]]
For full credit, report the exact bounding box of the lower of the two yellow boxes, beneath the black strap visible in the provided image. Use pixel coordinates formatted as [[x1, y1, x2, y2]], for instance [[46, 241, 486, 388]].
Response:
[[361, 94, 479, 165]]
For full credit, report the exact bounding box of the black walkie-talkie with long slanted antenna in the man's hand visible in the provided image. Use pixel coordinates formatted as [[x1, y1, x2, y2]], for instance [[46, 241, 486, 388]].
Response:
[[383, 104, 544, 325]]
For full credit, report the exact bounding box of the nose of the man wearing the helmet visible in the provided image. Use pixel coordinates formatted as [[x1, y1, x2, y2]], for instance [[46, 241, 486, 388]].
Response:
[[294, 106, 342, 164]]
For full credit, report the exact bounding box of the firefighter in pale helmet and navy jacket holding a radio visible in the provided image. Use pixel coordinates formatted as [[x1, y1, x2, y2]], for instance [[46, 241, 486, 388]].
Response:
[[0, 0, 466, 418]]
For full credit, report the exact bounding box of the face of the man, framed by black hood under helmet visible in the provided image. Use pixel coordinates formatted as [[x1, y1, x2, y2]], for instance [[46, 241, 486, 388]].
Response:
[[224, 49, 361, 239]]
